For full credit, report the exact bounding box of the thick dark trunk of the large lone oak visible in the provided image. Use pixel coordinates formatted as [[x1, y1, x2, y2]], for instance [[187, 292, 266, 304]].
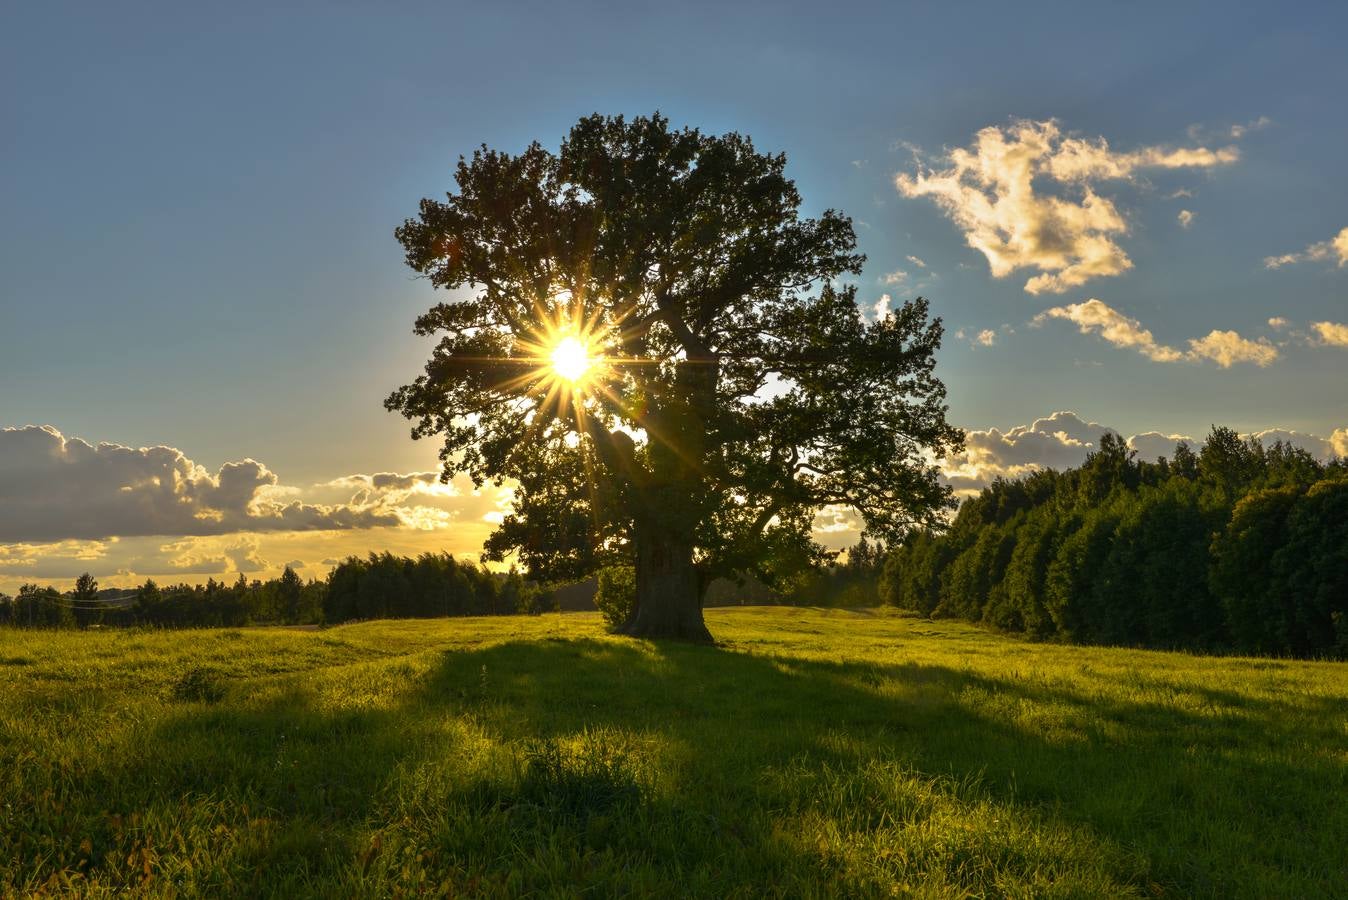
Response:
[[620, 521, 712, 644]]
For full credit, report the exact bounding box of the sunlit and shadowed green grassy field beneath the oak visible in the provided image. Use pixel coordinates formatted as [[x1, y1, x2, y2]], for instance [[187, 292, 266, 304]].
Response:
[[0, 608, 1348, 897]]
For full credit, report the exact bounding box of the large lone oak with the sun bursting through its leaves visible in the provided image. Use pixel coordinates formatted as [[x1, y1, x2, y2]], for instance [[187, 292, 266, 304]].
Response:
[[387, 115, 962, 640]]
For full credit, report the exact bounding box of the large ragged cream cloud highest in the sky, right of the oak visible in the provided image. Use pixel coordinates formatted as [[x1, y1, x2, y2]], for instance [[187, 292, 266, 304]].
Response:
[[895, 120, 1239, 294]]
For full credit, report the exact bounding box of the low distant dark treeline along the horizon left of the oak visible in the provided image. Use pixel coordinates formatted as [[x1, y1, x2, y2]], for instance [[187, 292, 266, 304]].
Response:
[[0, 552, 550, 628]]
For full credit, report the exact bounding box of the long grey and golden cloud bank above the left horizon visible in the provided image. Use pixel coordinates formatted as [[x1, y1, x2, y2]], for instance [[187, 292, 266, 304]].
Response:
[[0, 427, 514, 593]]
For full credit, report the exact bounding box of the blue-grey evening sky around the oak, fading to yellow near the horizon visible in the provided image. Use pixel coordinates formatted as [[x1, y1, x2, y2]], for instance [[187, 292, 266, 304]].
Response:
[[0, 3, 1348, 587]]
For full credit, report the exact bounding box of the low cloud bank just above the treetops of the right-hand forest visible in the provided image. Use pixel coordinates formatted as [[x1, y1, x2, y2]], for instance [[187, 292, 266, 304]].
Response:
[[941, 411, 1348, 496]]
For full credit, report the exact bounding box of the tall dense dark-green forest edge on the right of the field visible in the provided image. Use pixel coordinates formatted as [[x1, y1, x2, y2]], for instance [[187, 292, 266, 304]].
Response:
[[880, 427, 1348, 657]]
